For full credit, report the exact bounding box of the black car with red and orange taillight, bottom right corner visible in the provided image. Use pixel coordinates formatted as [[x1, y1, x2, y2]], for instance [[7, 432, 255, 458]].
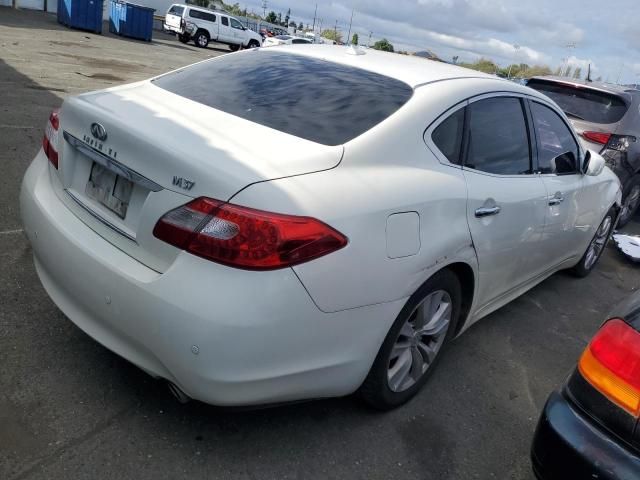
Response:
[[531, 293, 640, 480]]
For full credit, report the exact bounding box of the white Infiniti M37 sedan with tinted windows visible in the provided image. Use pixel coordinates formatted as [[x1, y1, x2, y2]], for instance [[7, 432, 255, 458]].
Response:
[[20, 45, 621, 408]]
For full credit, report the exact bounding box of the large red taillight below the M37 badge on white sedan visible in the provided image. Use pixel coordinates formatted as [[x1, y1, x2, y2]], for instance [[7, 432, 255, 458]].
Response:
[[153, 197, 347, 270]]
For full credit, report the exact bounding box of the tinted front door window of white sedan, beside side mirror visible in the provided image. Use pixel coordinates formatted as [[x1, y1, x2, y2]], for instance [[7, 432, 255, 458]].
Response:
[[531, 102, 579, 174]]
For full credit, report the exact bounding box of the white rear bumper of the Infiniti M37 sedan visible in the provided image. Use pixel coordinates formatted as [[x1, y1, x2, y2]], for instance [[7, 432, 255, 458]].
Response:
[[20, 152, 404, 405]]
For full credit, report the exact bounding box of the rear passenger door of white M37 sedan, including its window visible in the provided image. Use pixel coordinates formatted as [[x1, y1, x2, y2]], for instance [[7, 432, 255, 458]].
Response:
[[463, 95, 547, 310]]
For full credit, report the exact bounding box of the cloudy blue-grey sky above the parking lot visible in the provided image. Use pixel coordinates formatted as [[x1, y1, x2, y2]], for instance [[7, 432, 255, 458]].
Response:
[[239, 0, 640, 83]]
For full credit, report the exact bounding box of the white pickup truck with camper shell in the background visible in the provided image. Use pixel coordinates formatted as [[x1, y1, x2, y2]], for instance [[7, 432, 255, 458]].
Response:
[[164, 4, 262, 50]]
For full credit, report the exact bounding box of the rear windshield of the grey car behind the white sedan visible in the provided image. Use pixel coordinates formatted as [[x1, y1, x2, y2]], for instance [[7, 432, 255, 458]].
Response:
[[527, 80, 628, 123]]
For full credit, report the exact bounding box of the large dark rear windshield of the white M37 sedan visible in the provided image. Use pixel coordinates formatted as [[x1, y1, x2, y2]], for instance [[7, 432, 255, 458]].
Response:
[[154, 50, 413, 145]]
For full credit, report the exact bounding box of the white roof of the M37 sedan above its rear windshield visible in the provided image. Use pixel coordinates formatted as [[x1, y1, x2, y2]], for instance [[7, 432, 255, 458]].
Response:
[[270, 44, 496, 88]]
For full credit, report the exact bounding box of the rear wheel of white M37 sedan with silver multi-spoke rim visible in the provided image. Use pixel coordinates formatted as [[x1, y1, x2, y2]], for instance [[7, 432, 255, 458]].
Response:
[[359, 270, 462, 410]]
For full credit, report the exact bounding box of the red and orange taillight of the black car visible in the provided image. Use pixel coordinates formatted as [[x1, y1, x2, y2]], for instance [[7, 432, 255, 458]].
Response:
[[578, 318, 640, 417]]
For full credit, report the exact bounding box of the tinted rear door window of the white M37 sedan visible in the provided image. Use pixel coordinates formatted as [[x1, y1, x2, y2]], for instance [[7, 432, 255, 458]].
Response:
[[466, 97, 531, 175]]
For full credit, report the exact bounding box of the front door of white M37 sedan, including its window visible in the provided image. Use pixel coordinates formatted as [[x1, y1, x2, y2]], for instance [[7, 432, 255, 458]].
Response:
[[529, 100, 584, 265]]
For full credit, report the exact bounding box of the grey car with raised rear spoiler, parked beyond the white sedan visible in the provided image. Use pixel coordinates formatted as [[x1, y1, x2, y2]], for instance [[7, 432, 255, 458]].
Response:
[[528, 77, 640, 226]]
